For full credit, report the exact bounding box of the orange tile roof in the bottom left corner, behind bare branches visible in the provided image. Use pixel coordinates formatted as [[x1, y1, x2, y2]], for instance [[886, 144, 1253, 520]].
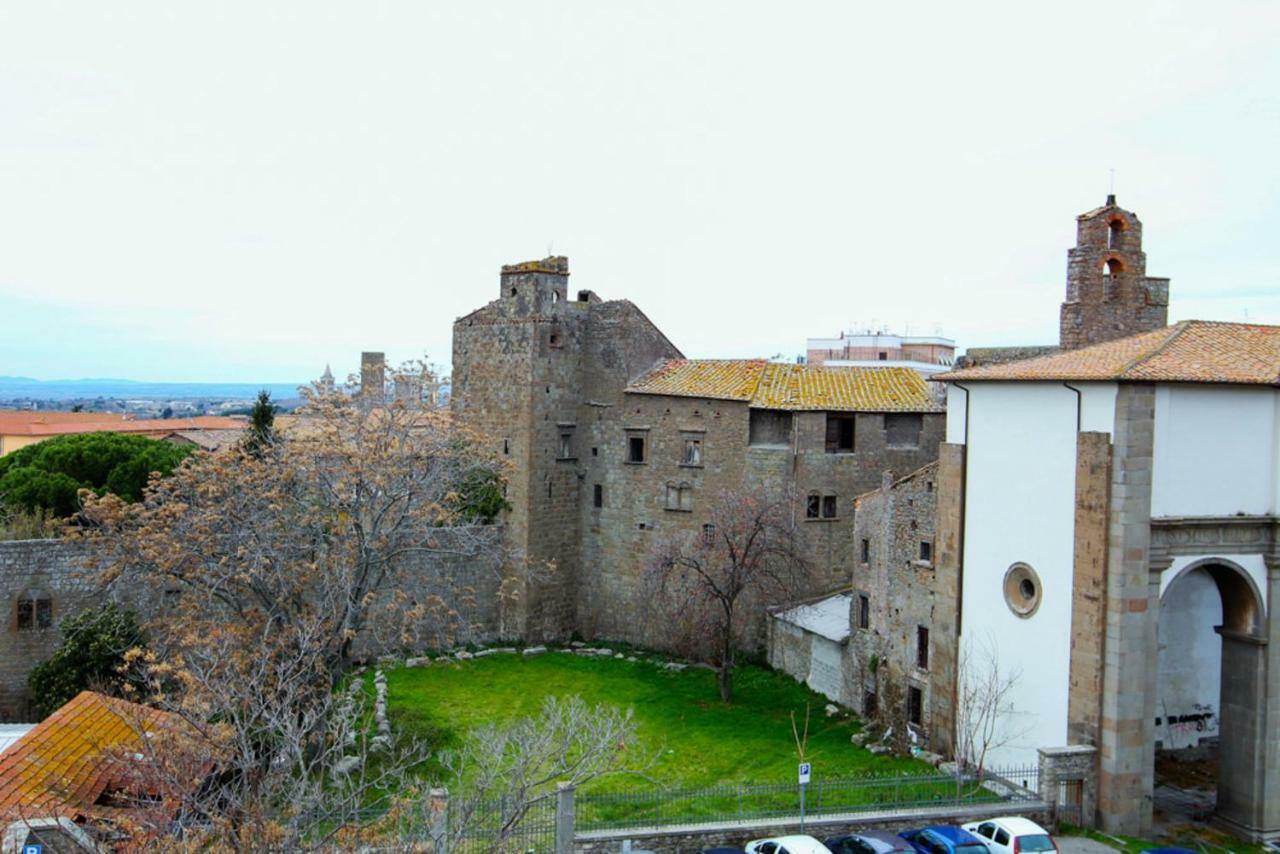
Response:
[[0, 691, 197, 822]]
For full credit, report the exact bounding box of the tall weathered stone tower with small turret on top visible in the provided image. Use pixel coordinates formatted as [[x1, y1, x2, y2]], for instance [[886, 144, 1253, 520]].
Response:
[[451, 256, 680, 641]]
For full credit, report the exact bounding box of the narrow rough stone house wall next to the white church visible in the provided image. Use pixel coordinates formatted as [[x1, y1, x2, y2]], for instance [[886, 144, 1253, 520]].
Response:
[[849, 462, 945, 732]]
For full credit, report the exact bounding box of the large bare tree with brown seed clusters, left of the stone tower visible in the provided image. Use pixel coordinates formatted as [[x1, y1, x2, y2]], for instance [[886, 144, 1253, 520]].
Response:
[[77, 386, 502, 850]]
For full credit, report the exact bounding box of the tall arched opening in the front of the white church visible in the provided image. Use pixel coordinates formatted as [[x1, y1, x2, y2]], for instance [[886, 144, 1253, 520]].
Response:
[[1153, 557, 1267, 827]]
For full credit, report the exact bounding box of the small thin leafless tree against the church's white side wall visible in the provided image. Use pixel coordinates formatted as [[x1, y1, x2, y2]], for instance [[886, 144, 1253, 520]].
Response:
[[956, 635, 1025, 777]]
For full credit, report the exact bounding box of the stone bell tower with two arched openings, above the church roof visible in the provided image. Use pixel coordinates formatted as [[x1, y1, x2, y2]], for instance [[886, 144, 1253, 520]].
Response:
[[1059, 196, 1169, 350]]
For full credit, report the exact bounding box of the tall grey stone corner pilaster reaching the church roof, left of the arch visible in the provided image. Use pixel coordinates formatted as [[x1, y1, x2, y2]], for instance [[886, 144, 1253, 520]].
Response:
[[1098, 384, 1160, 836]]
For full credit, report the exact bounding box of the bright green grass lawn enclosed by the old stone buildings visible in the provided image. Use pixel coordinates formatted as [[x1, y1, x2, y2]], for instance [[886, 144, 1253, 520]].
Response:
[[388, 652, 924, 790]]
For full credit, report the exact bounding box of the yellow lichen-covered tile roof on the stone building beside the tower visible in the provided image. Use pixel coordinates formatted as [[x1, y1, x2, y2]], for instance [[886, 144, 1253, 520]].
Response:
[[627, 359, 942, 412]]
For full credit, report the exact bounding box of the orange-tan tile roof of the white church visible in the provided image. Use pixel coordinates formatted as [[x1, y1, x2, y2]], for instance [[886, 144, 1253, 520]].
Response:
[[934, 320, 1280, 385]]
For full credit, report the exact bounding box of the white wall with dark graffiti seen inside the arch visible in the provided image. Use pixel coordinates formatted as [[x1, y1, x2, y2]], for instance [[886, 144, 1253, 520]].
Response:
[[1156, 568, 1222, 748]]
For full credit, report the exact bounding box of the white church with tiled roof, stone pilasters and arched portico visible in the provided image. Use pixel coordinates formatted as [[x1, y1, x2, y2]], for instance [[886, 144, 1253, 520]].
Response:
[[943, 321, 1280, 837]]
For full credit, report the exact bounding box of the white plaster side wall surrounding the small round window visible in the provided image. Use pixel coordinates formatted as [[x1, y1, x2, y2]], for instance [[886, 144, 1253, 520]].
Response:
[[948, 383, 1080, 764]]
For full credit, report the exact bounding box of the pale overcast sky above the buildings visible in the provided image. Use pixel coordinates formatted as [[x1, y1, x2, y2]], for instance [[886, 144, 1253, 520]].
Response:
[[0, 0, 1280, 382]]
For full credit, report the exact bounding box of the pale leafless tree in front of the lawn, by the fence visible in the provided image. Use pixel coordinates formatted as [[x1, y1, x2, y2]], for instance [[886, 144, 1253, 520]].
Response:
[[442, 697, 653, 851]]
